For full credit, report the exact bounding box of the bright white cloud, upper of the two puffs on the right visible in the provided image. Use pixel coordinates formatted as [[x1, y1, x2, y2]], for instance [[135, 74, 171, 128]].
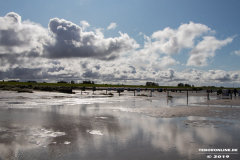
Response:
[[148, 22, 214, 55]]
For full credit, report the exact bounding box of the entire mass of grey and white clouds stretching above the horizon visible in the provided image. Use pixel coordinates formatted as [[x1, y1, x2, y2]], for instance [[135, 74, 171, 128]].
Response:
[[0, 12, 240, 84]]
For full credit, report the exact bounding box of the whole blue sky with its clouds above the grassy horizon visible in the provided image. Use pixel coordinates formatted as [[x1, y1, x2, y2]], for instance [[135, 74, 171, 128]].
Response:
[[0, 0, 240, 87]]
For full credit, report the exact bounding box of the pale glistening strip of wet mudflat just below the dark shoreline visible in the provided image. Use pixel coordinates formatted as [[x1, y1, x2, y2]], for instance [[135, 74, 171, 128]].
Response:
[[0, 91, 217, 108]]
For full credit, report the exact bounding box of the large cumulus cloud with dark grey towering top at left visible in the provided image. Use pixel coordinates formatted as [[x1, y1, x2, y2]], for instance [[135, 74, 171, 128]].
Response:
[[0, 12, 139, 63]]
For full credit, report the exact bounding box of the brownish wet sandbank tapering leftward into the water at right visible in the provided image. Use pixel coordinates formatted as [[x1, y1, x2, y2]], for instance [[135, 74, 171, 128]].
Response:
[[120, 92, 240, 120]]
